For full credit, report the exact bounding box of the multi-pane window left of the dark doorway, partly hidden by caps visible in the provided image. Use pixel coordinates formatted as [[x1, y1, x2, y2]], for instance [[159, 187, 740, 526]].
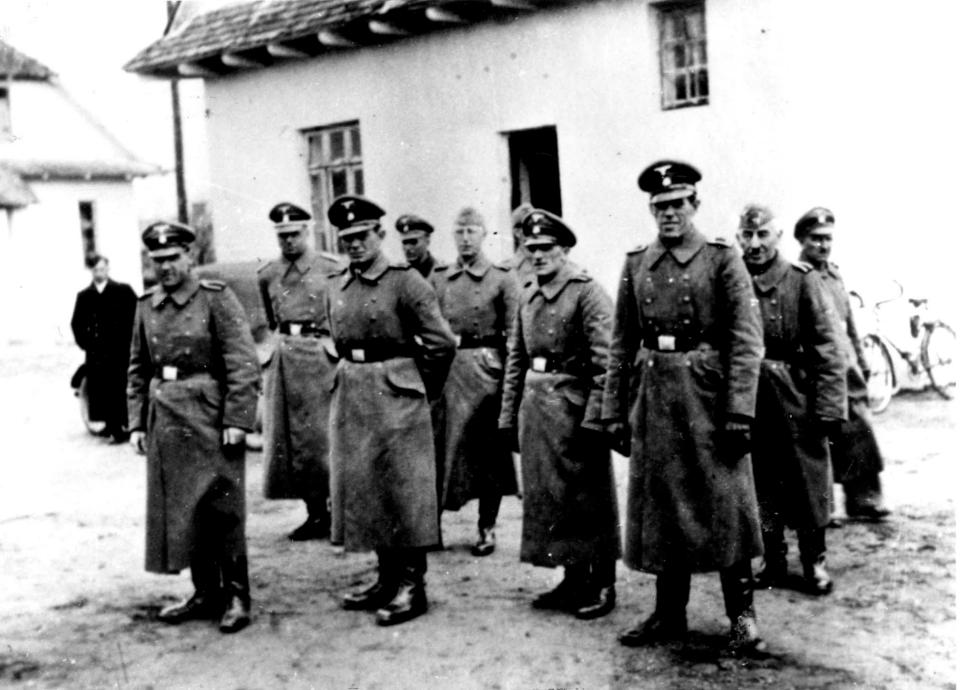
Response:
[[304, 122, 363, 251]]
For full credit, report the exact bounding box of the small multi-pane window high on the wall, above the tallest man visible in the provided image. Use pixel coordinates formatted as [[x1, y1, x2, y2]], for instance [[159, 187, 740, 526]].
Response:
[[657, 2, 710, 110]]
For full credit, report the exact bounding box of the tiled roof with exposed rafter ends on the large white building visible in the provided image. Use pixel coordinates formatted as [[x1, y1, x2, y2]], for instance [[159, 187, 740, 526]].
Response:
[[124, 0, 570, 77]]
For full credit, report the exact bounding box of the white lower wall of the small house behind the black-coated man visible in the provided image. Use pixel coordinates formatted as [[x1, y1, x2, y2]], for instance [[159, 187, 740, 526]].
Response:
[[0, 182, 142, 344]]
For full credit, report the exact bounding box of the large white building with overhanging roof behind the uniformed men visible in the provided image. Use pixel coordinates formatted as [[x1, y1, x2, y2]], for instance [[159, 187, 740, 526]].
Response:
[[126, 0, 952, 300]]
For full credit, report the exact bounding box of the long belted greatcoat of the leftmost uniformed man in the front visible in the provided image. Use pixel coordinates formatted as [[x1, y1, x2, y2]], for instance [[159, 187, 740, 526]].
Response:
[[127, 275, 260, 573]]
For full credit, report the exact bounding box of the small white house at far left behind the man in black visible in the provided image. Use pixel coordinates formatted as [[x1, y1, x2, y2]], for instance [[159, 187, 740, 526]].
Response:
[[0, 42, 159, 342]]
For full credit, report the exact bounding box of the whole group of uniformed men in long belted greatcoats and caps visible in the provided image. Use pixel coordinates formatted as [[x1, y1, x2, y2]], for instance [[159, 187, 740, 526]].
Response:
[[128, 161, 886, 653]]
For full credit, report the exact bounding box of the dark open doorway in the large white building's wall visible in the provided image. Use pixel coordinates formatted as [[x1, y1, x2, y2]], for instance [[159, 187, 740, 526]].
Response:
[[506, 127, 563, 216]]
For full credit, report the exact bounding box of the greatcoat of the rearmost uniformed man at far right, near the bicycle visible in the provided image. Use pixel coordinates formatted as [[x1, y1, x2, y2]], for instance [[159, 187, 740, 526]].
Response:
[[818, 263, 883, 486]]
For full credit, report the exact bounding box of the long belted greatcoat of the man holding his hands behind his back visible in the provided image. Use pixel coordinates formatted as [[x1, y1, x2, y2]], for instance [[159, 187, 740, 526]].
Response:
[[327, 254, 456, 551]]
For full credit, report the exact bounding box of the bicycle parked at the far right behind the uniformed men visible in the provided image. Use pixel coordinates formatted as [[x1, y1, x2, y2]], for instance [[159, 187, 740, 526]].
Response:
[[850, 281, 958, 414]]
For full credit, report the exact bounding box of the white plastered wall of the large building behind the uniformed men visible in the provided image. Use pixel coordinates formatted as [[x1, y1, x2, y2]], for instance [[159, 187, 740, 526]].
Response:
[[206, 0, 952, 298]]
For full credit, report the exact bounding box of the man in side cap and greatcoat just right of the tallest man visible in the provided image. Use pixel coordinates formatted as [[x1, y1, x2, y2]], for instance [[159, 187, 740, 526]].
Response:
[[737, 204, 847, 594]]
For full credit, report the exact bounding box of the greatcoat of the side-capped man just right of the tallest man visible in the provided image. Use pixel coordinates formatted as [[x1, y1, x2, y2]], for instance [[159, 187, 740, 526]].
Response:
[[751, 254, 847, 530]]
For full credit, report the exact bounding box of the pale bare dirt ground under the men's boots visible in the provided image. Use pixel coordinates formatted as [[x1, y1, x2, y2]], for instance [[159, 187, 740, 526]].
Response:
[[0, 346, 958, 689]]
